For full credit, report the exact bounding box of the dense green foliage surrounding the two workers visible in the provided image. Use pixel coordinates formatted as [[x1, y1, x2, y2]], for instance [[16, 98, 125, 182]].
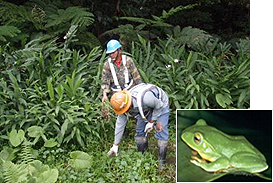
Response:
[[0, 0, 250, 182]]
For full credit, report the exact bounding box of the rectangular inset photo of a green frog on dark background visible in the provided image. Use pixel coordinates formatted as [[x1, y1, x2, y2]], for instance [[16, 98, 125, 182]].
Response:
[[176, 109, 272, 182]]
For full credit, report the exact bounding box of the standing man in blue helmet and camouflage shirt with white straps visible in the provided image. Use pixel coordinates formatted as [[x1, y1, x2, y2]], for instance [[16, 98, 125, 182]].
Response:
[[101, 39, 142, 102]]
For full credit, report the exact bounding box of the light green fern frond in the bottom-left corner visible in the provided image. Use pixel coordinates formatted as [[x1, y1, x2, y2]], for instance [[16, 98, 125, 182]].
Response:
[[2, 161, 28, 183]]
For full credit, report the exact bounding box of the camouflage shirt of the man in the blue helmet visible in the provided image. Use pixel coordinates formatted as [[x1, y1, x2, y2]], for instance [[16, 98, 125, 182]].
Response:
[[101, 56, 142, 93]]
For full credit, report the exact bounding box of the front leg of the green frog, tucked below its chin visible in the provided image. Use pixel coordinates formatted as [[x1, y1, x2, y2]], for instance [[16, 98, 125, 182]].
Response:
[[191, 157, 230, 172]]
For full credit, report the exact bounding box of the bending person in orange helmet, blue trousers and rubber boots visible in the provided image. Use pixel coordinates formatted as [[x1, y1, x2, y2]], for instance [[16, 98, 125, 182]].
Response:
[[108, 83, 169, 167]]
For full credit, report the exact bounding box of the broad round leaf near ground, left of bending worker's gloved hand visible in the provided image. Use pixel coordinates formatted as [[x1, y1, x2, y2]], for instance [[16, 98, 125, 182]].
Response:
[[69, 151, 91, 169]]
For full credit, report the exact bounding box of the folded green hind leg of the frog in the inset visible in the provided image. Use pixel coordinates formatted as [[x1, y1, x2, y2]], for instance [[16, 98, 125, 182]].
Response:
[[230, 152, 268, 173]]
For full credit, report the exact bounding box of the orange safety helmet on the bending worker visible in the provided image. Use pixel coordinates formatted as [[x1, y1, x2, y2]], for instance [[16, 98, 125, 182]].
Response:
[[110, 90, 132, 115]]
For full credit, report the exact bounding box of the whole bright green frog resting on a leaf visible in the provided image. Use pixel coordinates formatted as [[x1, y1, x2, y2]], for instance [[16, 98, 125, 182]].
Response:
[[181, 119, 268, 173]]
